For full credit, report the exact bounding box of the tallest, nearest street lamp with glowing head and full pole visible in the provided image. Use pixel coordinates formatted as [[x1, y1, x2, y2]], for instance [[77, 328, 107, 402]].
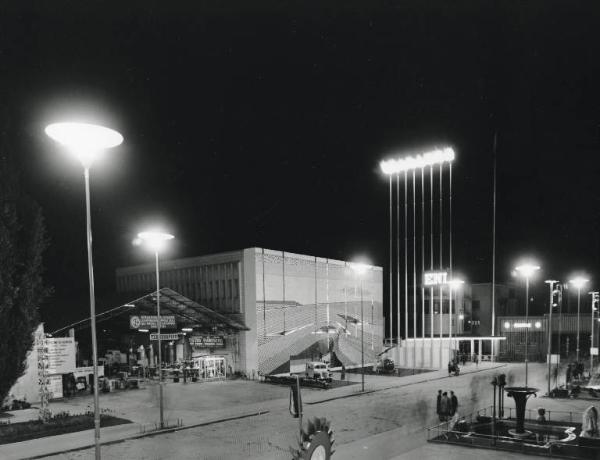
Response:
[[45, 122, 123, 459]]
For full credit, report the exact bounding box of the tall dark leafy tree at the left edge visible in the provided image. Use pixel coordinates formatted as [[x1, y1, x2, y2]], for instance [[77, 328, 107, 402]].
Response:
[[0, 125, 50, 403]]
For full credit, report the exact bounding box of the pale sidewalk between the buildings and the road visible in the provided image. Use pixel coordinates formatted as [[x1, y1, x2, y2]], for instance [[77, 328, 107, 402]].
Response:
[[0, 363, 505, 460]]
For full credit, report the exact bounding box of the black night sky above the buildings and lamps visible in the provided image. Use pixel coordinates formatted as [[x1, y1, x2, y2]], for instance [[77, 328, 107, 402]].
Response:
[[0, 1, 600, 328]]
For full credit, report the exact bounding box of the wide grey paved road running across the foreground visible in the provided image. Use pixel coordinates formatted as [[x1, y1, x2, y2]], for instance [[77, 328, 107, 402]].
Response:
[[39, 366, 589, 460]]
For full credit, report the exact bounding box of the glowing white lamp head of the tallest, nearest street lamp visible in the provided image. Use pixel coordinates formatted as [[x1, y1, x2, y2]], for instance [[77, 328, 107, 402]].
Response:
[[44, 122, 123, 169]]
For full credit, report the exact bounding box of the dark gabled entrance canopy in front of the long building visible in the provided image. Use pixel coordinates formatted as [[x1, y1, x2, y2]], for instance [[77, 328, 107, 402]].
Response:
[[52, 288, 249, 335]]
